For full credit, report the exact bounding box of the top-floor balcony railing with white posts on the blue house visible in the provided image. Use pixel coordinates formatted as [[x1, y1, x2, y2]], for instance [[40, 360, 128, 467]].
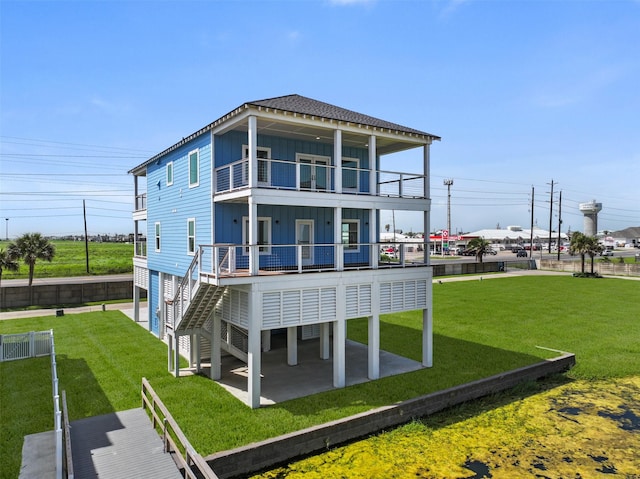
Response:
[[215, 159, 426, 198]]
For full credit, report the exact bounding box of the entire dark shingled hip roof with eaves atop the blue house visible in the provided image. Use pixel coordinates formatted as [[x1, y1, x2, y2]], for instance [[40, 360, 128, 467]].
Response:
[[129, 95, 440, 173]]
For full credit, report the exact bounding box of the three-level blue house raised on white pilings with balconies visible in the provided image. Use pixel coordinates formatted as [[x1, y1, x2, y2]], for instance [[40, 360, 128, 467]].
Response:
[[130, 95, 440, 408]]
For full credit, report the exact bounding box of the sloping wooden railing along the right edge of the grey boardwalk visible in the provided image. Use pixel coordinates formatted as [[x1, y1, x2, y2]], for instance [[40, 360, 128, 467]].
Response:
[[142, 378, 218, 479]]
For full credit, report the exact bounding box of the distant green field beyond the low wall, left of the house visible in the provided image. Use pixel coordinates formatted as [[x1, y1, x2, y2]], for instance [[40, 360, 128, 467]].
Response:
[[0, 241, 134, 280]]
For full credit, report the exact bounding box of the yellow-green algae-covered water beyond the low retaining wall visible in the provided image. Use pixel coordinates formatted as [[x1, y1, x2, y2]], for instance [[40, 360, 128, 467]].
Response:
[[253, 376, 640, 479]]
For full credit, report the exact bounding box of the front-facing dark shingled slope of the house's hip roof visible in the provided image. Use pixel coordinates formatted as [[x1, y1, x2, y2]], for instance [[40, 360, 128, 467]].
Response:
[[247, 95, 440, 140]]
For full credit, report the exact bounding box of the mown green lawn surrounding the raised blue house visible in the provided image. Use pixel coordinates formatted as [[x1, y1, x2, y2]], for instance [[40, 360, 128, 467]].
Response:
[[0, 276, 640, 478]]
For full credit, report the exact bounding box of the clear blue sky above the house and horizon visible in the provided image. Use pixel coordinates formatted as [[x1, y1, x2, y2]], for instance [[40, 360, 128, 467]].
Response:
[[0, 0, 640, 238]]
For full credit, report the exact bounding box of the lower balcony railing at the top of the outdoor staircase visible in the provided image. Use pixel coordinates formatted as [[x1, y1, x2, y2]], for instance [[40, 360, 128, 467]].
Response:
[[192, 241, 425, 278]]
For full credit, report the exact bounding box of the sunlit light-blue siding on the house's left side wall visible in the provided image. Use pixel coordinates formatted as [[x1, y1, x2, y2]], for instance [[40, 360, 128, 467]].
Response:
[[147, 134, 212, 276]]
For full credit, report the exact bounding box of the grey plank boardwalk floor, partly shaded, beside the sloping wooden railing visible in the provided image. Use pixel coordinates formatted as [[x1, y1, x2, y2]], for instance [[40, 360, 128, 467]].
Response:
[[71, 408, 182, 479]]
